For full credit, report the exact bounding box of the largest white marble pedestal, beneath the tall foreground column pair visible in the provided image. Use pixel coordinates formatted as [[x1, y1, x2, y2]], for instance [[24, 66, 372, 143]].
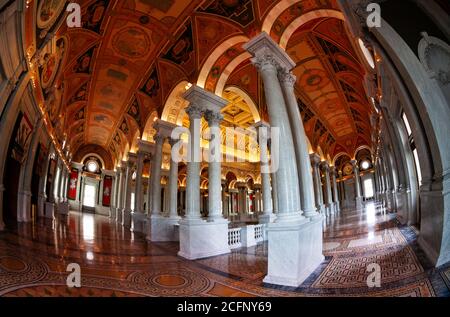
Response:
[[264, 217, 324, 287]]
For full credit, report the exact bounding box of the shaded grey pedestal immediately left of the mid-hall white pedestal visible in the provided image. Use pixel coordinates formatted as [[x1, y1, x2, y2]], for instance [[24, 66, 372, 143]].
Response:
[[147, 215, 180, 242]]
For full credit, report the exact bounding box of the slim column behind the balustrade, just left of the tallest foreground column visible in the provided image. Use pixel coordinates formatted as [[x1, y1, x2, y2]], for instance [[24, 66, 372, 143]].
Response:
[[255, 121, 275, 223]]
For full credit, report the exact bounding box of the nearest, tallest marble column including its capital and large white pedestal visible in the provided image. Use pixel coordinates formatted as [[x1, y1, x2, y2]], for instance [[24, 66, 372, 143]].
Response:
[[244, 32, 324, 287]]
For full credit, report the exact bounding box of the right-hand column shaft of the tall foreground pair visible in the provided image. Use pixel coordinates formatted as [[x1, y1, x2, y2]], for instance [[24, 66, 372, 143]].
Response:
[[278, 69, 318, 218]]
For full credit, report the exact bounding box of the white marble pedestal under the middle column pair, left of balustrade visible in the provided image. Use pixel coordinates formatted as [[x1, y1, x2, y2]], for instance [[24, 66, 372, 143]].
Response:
[[178, 219, 231, 260]]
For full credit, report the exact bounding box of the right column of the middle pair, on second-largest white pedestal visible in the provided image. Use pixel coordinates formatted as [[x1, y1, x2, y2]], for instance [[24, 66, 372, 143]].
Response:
[[205, 110, 225, 222]]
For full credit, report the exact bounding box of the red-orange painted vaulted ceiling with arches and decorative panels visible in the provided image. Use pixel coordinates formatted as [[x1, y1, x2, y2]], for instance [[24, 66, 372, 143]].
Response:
[[25, 0, 371, 167]]
